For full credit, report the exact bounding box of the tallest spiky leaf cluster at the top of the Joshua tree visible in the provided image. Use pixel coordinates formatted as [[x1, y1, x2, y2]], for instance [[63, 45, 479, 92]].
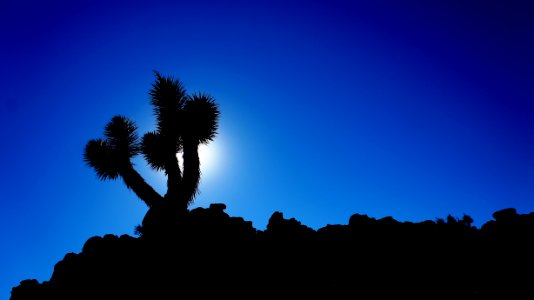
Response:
[[148, 71, 187, 136]]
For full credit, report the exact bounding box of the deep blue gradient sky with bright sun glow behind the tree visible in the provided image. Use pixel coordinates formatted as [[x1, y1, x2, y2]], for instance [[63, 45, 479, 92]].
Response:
[[0, 0, 534, 299]]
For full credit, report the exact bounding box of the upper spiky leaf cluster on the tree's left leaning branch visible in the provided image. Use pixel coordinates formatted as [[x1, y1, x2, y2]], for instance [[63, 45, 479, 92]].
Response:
[[104, 116, 139, 159]]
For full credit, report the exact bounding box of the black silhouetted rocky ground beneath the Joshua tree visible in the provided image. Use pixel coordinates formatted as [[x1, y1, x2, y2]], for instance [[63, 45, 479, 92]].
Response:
[[10, 204, 534, 300]]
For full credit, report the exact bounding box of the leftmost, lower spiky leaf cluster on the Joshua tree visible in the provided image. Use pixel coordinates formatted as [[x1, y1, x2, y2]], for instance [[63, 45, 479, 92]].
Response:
[[83, 139, 120, 180]]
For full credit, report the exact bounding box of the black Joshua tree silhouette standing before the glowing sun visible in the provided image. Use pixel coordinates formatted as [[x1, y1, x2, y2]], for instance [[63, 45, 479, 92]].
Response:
[[83, 71, 220, 233]]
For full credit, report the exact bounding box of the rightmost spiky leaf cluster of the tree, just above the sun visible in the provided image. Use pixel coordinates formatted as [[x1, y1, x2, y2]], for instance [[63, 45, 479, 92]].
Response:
[[183, 93, 220, 144]]
